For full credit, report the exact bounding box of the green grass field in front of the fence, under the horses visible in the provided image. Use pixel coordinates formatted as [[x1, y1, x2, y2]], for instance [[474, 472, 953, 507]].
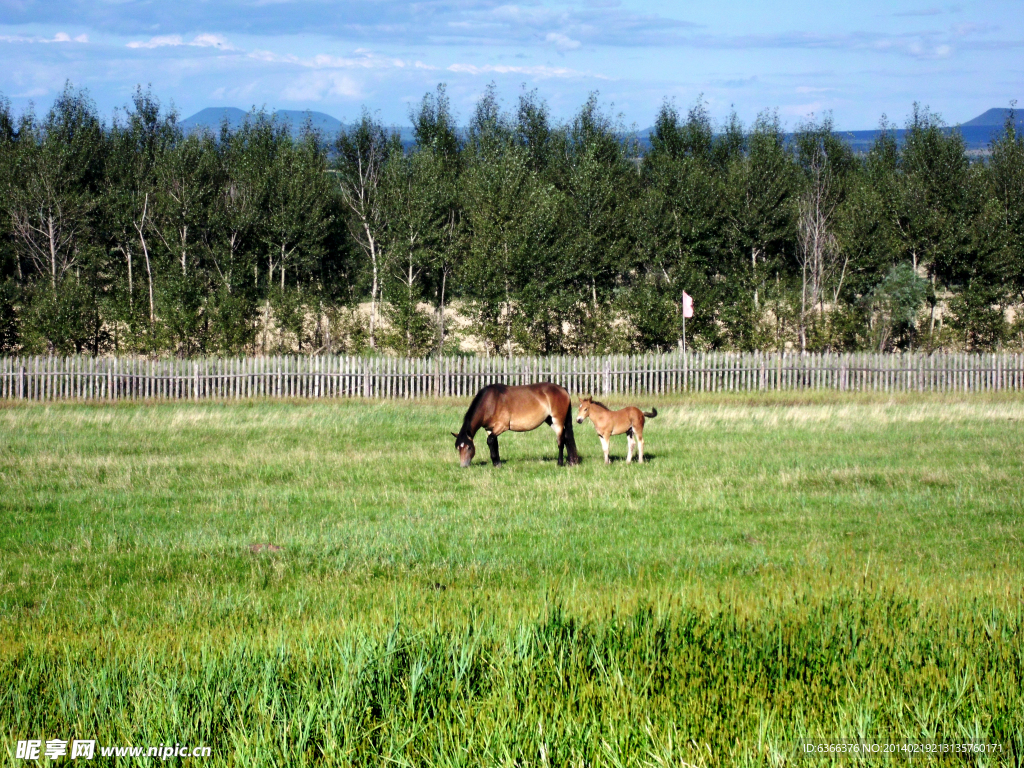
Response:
[[0, 393, 1024, 766]]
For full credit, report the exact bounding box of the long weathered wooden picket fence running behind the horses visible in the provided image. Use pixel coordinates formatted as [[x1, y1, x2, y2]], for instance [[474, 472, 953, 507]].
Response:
[[0, 352, 1024, 400]]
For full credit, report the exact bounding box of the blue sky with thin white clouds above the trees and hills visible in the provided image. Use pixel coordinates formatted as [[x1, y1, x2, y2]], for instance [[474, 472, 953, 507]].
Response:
[[0, 0, 1024, 129]]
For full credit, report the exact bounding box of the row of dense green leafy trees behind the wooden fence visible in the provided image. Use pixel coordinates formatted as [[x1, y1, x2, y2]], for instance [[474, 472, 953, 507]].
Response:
[[0, 86, 1024, 355]]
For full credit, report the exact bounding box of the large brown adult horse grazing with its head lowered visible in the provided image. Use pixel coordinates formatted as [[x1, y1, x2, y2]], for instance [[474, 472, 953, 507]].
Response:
[[452, 382, 580, 467]]
